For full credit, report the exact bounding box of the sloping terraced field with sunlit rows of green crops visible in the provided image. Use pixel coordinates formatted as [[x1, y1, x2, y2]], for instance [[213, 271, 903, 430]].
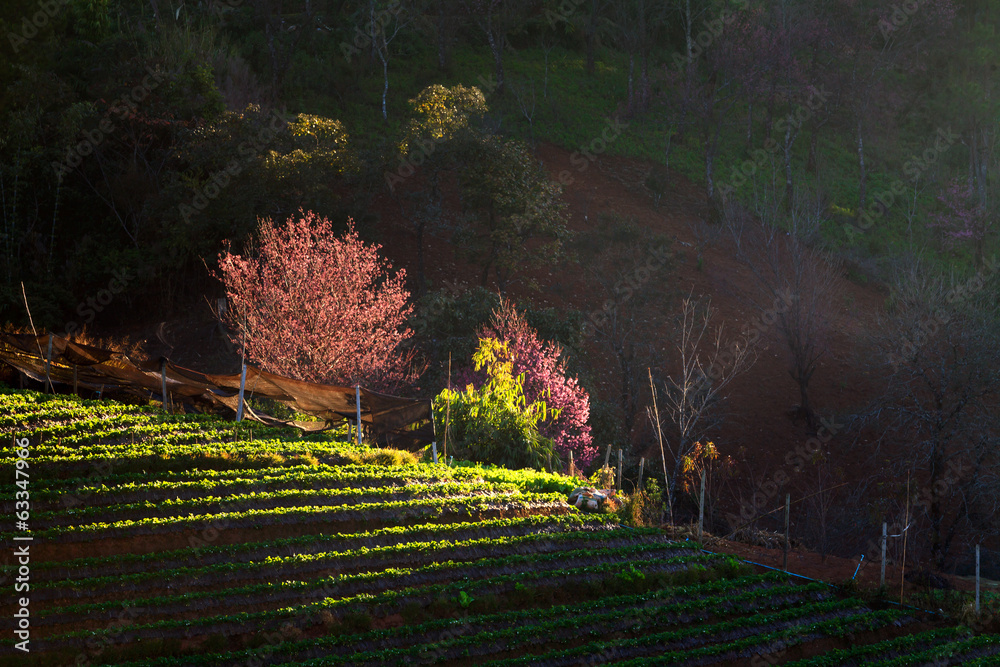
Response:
[[0, 390, 1000, 666]]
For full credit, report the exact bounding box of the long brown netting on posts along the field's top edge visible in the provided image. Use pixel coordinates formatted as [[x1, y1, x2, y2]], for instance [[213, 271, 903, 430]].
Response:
[[0, 333, 434, 449]]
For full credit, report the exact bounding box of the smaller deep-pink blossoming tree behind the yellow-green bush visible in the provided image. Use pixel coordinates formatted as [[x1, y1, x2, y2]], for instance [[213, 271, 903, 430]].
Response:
[[472, 299, 597, 467]]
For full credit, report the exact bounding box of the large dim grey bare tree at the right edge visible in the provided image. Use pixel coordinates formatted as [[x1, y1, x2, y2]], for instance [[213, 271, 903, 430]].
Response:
[[863, 265, 1000, 568]]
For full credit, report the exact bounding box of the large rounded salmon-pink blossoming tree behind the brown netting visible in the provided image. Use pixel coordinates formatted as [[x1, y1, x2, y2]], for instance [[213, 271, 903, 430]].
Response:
[[216, 210, 416, 391]]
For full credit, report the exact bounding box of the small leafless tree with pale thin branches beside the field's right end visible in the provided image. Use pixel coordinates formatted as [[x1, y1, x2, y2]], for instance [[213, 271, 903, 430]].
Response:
[[656, 296, 757, 511]]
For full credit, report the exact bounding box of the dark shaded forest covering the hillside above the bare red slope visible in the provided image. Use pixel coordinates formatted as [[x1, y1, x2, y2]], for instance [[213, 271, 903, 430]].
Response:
[[0, 0, 1000, 326]]
